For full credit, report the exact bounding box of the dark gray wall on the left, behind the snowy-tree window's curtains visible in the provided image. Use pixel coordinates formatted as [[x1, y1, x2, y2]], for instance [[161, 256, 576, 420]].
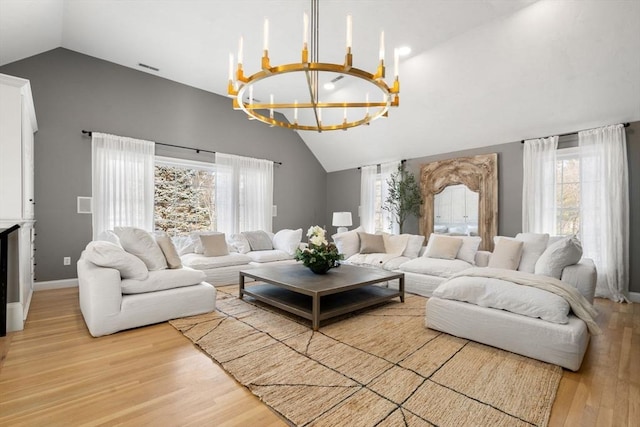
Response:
[[0, 48, 327, 281]]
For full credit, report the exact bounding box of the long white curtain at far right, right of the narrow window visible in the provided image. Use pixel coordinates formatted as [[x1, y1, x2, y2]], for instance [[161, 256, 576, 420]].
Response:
[[578, 125, 629, 302]]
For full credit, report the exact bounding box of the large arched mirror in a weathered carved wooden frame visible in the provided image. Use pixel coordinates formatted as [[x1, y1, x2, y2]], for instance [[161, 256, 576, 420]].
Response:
[[420, 153, 498, 251]]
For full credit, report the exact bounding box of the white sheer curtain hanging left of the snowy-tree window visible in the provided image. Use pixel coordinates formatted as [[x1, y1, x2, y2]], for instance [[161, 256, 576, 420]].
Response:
[[91, 132, 155, 240]]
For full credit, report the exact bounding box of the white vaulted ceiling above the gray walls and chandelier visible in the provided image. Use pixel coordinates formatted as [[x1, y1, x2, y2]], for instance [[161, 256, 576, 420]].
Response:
[[0, 0, 640, 172]]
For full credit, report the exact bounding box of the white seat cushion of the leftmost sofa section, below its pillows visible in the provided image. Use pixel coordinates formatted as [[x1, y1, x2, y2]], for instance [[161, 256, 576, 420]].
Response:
[[120, 268, 206, 294]]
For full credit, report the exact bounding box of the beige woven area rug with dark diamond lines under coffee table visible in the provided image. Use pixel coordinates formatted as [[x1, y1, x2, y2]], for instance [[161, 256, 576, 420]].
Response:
[[171, 286, 562, 427]]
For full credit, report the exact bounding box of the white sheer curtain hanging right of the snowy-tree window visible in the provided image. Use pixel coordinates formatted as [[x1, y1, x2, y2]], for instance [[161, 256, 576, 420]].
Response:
[[216, 153, 273, 233]]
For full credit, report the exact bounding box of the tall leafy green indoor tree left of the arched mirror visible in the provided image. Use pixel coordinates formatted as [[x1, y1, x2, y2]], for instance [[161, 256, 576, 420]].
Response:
[[382, 162, 422, 234]]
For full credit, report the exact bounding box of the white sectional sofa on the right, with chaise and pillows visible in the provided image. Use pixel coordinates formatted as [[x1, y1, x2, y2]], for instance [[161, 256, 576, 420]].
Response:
[[333, 230, 597, 371]]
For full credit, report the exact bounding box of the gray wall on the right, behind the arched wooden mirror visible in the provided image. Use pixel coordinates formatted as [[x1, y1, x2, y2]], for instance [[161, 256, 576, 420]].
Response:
[[326, 122, 640, 292]]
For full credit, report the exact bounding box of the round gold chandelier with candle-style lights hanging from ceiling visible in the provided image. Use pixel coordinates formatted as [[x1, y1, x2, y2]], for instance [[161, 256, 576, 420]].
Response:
[[228, 0, 400, 132]]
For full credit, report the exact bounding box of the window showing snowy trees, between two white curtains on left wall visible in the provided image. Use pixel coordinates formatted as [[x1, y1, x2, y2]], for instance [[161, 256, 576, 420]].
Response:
[[154, 157, 216, 236]]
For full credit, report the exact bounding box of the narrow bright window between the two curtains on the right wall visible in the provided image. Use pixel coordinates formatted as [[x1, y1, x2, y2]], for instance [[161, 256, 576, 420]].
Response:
[[556, 148, 580, 235]]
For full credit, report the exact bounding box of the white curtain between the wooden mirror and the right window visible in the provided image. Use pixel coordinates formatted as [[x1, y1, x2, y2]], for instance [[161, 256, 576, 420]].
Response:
[[522, 136, 558, 234]]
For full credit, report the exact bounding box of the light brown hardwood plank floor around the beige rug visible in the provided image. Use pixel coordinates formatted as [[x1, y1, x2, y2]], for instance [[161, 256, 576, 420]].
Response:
[[0, 288, 640, 426]]
